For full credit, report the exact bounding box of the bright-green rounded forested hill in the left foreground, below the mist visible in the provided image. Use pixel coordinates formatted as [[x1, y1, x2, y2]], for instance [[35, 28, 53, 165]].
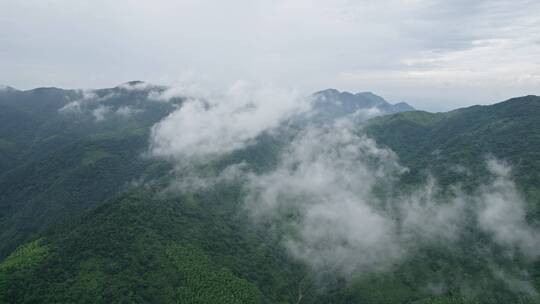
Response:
[[0, 190, 310, 303]]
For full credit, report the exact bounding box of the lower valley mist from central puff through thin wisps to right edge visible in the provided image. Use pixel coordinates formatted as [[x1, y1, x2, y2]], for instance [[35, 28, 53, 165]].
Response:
[[246, 121, 540, 277]]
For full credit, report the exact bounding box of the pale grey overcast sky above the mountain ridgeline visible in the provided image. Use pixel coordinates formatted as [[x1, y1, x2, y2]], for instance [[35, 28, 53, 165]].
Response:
[[0, 0, 540, 110]]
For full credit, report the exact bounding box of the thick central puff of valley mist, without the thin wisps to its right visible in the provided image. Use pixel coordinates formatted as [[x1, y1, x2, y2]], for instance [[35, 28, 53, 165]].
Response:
[[247, 123, 404, 273]]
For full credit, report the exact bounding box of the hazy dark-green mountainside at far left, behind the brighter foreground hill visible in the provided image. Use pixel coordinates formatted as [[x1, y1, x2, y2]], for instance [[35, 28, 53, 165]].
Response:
[[0, 85, 177, 257]]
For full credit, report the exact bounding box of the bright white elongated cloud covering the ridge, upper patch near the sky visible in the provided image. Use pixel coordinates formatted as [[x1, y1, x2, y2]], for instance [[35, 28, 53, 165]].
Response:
[[150, 82, 309, 159]]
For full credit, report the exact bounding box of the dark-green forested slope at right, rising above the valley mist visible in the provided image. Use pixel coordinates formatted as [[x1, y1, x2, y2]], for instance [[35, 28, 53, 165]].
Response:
[[366, 96, 540, 198]]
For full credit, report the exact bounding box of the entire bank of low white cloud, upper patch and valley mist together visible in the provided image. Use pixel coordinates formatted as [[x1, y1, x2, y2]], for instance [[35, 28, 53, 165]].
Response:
[[150, 83, 540, 290]]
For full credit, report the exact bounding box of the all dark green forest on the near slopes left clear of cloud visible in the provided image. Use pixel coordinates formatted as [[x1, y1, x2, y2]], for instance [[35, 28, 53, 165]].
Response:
[[0, 84, 540, 304]]
